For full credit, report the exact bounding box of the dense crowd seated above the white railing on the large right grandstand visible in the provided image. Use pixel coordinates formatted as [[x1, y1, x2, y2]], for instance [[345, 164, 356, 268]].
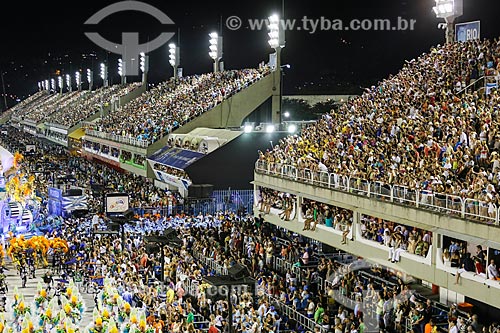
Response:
[[259, 38, 500, 216]]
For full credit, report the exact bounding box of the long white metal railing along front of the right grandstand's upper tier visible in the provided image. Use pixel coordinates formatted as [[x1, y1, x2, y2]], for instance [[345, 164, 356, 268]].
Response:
[[255, 160, 500, 226]]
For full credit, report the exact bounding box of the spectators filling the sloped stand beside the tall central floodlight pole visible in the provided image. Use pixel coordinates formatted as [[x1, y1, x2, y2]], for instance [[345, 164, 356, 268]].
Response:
[[92, 67, 269, 142]]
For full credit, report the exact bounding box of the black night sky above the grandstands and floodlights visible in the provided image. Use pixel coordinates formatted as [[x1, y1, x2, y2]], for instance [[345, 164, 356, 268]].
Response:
[[0, 0, 500, 107]]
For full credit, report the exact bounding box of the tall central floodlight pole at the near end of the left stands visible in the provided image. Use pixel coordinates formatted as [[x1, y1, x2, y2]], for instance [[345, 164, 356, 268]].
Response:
[[268, 14, 290, 124]]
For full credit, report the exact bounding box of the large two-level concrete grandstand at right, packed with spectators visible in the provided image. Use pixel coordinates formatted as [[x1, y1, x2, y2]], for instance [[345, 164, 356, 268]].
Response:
[[254, 39, 500, 320]]
